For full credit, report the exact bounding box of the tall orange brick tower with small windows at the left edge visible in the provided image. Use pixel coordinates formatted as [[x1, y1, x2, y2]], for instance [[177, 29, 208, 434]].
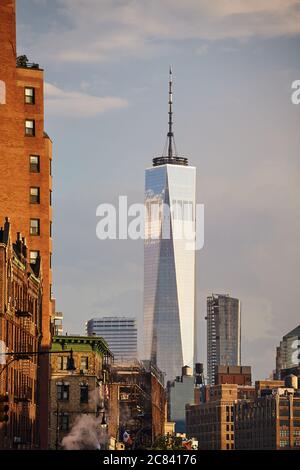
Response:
[[0, 0, 52, 448]]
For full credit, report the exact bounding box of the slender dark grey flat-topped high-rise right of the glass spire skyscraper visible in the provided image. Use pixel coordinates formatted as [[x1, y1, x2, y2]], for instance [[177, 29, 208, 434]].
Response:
[[206, 294, 241, 385]]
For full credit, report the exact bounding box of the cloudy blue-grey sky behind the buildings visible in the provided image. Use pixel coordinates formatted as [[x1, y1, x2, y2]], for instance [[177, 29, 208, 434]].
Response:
[[17, 0, 300, 378]]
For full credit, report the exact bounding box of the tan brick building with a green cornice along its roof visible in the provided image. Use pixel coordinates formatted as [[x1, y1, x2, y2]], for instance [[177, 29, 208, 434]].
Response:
[[49, 336, 111, 449]]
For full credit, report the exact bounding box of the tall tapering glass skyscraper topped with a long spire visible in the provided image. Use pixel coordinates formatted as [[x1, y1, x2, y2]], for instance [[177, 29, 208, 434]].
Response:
[[143, 70, 196, 380]]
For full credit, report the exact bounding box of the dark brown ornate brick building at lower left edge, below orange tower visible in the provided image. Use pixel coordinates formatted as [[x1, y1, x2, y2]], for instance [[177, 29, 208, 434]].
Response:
[[0, 219, 42, 449]]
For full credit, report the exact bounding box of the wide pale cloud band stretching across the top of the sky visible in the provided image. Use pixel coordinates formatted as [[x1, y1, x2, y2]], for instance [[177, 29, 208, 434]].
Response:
[[21, 0, 300, 63]]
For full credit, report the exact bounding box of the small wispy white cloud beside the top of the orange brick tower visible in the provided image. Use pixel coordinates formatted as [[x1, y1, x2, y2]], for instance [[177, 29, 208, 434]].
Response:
[[45, 83, 128, 118]]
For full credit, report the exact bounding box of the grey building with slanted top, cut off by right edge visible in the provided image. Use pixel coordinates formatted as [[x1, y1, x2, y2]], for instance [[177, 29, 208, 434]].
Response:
[[276, 325, 300, 379]]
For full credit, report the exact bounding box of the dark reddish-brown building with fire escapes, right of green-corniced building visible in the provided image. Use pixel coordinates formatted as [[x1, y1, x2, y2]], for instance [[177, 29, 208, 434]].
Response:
[[109, 361, 167, 448]]
